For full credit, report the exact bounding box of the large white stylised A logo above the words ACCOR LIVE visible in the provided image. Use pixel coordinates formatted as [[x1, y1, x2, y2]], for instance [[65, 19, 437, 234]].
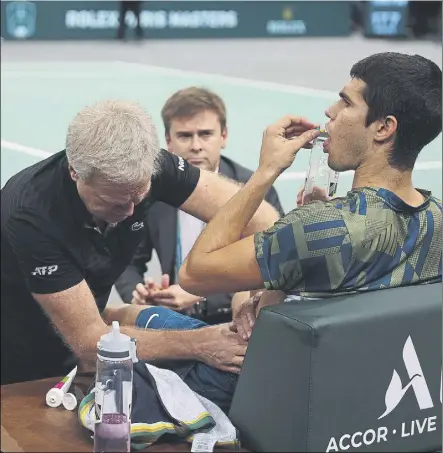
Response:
[[378, 336, 442, 420]]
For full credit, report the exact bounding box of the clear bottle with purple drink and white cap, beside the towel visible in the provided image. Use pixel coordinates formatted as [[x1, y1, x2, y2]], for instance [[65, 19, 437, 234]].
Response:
[[94, 321, 138, 453]]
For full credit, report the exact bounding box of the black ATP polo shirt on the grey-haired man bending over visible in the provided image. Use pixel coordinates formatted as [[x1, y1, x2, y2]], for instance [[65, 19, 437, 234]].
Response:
[[1, 150, 200, 384]]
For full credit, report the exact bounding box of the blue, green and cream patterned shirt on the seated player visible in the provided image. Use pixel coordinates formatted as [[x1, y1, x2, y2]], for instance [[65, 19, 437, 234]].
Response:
[[254, 187, 442, 298]]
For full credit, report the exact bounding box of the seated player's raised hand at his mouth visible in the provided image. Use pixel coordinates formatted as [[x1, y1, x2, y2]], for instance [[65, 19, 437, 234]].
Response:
[[259, 115, 320, 177]]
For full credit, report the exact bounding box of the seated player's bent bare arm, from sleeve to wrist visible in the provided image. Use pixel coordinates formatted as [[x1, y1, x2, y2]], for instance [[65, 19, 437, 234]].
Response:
[[179, 164, 290, 296]]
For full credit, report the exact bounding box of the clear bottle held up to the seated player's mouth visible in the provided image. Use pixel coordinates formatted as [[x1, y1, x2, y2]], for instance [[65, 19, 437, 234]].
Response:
[[303, 129, 339, 204]]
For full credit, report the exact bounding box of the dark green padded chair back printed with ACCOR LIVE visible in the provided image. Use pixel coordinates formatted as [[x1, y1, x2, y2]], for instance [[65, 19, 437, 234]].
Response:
[[229, 283, 442, 452]]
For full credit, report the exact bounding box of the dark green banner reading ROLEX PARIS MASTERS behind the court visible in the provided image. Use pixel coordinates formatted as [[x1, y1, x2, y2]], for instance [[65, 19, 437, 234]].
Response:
[[1, 1, 350, 40]]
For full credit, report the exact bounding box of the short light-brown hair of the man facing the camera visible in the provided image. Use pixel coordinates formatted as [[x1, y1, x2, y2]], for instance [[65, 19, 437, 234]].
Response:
[[162, 87, 226, 134]]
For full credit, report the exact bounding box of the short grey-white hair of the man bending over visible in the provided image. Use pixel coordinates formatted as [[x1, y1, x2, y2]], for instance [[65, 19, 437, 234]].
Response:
[[66, 100, 160, 184]]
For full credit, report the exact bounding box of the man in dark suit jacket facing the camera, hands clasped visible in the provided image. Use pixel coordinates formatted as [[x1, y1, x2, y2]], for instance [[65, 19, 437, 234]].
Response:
[[115, 87, 283, 324]]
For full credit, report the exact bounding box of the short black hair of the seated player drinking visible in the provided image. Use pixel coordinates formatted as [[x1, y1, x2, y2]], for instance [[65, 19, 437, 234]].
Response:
[[350, 52, 442, 170]]
